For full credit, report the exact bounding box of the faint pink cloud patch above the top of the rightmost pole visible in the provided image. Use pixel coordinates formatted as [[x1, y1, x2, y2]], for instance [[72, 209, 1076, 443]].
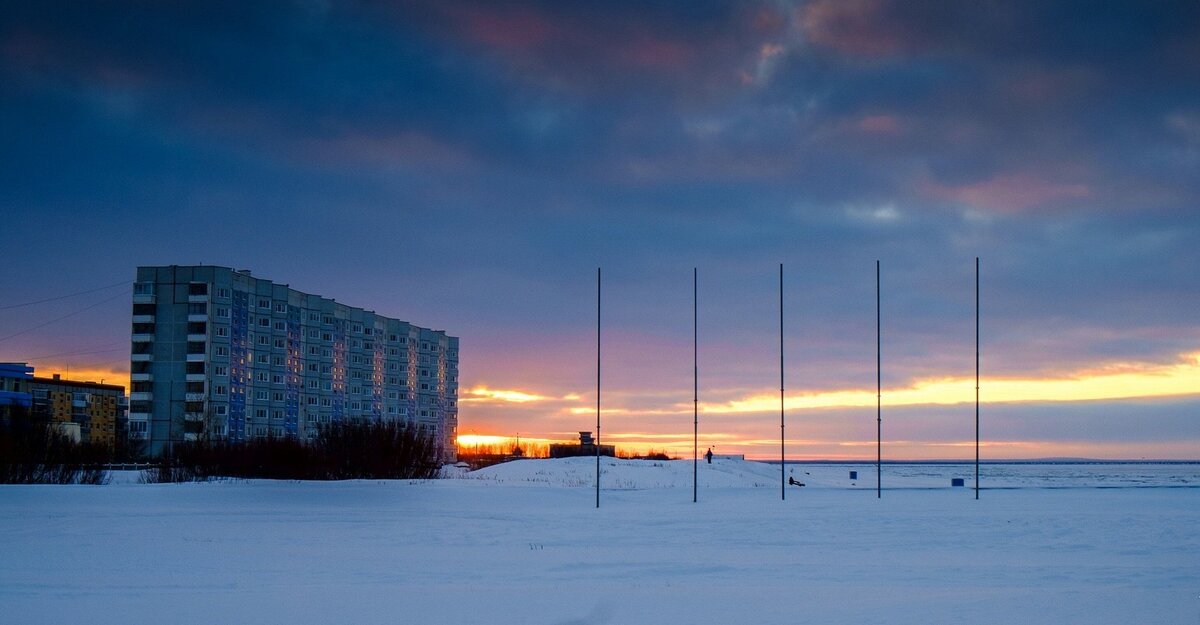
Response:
[[923, 173, 1092, 212]]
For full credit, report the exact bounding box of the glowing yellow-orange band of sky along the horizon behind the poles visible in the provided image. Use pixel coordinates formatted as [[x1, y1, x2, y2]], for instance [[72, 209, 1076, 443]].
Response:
[[451, 351, 1200, 459]]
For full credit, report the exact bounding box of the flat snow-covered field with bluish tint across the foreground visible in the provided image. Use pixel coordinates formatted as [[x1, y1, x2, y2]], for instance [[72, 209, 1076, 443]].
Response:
[[0, 458, 1200, 625]]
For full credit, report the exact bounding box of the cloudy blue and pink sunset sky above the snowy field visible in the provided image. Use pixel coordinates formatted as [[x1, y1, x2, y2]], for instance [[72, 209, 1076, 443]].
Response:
[[0, 0, 1200, 459]]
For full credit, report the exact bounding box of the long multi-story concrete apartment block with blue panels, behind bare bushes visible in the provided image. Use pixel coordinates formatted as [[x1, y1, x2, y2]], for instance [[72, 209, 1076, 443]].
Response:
[[130, 265, 458, 461]]
